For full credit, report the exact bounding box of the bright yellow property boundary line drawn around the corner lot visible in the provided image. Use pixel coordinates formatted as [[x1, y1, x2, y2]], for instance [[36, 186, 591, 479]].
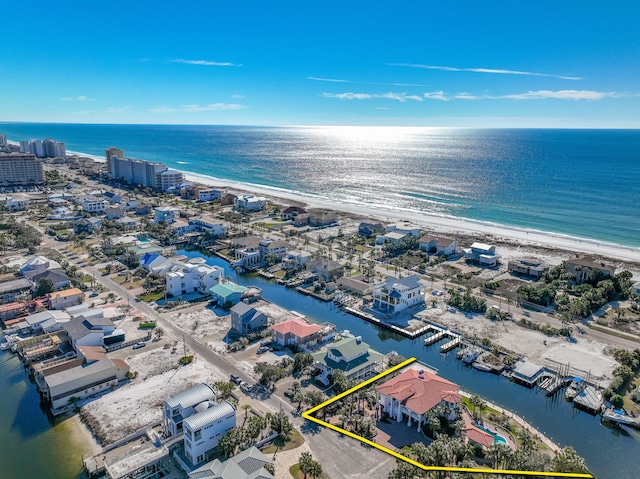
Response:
[[302, 358, 593, 479]]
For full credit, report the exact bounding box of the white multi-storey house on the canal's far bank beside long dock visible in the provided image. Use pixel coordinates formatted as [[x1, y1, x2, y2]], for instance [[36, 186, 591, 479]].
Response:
[[372, 274, 424, 314]]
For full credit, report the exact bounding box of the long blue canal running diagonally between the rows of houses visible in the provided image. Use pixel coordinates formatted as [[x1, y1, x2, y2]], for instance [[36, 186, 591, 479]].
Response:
[[178, 250, 640, 479]]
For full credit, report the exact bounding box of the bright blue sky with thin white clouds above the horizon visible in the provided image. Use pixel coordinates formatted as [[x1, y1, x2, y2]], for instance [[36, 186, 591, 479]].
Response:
[[0, 0, 640, 128]]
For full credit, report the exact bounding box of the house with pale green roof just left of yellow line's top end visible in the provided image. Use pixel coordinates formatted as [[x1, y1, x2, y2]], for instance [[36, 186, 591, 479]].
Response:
[[312, 336, 384, 386]]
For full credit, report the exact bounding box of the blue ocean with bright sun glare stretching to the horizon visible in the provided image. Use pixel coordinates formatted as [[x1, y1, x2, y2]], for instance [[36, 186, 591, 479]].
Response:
[[0, 123, 640, 247]]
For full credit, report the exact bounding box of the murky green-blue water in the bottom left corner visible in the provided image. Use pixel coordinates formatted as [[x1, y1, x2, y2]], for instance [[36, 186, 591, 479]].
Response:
[[0, 351, 86, 479]]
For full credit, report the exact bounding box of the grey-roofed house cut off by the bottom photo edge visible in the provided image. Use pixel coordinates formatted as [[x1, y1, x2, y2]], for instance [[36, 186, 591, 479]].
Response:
[[189, 446, 273, 479]]
